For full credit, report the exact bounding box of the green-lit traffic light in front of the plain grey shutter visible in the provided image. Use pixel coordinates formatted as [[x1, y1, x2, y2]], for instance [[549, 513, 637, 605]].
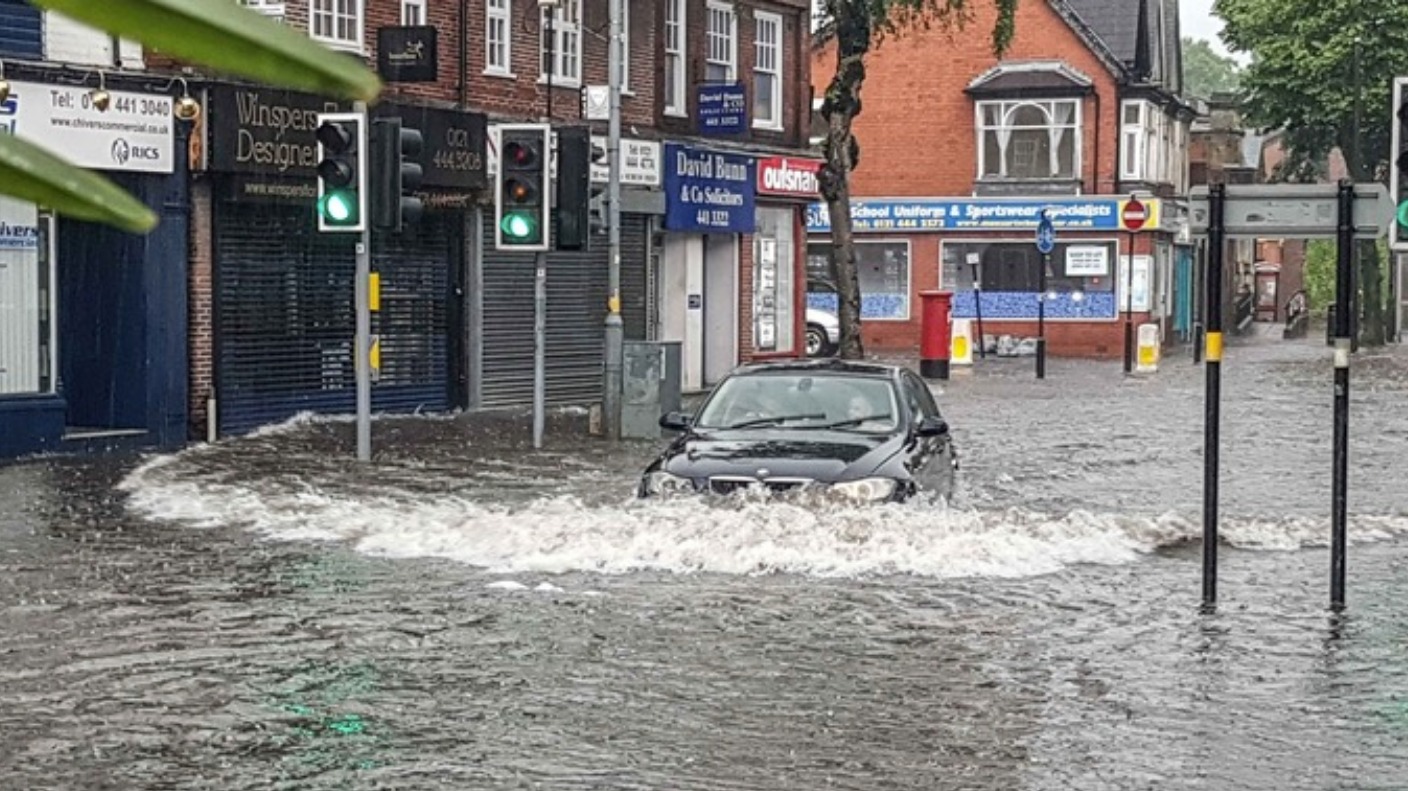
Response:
[[494, 124, 549, 252]]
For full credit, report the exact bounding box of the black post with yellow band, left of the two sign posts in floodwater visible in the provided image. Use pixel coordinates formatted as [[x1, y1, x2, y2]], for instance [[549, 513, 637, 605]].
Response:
[[1199, 184, 1226, 609]]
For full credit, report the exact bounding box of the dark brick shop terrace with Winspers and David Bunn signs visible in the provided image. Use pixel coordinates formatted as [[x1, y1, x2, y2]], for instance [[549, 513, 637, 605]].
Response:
[[148, 0, 819, 436]]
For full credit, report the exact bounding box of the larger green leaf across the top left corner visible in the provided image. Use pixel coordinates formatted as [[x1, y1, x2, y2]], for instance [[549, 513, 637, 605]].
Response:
[[30, 0, 382, 101]]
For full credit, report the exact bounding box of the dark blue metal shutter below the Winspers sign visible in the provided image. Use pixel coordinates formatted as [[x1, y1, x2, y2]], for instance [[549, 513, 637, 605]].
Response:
[[215, 203, 449, 435]]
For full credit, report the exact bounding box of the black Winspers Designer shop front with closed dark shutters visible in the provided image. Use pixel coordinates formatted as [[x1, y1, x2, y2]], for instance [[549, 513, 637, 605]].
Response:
[[193, 86, 487, 435]]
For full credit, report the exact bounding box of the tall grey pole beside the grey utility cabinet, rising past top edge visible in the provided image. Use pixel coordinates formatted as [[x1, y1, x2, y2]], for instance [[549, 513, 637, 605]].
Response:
[[601, 0, 625, 439]]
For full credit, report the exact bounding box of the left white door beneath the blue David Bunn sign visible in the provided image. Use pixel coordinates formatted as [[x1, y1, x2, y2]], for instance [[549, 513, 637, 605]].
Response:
[[656, 234, 704, 393]]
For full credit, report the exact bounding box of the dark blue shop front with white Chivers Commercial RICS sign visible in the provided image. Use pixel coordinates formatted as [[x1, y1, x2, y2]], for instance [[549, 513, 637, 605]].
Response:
[[0, 75, 189, 457]]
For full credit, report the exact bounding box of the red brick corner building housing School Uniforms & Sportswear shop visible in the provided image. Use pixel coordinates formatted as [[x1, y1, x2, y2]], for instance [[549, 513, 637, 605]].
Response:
[[808, 0, 1194, 357]]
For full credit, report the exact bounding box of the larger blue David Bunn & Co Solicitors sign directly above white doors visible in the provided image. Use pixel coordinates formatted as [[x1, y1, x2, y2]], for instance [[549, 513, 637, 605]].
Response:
[[665, 142, 758, 234]]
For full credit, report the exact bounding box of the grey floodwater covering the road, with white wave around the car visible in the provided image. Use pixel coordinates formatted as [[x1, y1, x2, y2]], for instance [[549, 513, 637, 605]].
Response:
[[0, 329, 1408, 791]]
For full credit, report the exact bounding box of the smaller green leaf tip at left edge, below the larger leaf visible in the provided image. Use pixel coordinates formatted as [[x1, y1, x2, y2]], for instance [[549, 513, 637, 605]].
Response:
[[0, 134, 156, 234]]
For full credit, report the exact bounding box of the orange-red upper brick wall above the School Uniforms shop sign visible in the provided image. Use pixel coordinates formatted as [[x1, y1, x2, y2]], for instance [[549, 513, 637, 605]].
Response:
[[812, 0, 1119, 197]]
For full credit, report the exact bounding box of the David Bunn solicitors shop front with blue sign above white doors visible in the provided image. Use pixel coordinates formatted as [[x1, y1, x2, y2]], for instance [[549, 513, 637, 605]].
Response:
[[658, 142, 760, 393]]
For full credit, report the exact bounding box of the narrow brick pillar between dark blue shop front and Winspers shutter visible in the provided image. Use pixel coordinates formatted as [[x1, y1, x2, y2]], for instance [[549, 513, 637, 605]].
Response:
[[186, 179, 215, 439]]
